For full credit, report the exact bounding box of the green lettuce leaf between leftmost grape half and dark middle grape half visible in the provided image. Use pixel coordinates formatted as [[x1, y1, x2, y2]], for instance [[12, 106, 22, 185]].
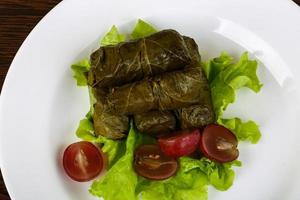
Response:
[[90, 125, 139, 200]]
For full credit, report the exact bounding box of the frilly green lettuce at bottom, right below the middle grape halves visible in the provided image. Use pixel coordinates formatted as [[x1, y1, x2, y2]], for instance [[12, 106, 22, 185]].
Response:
[[136, 158, 208, 200]]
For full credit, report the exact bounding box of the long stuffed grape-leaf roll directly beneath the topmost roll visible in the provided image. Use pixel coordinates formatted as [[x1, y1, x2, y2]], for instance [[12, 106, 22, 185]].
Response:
[[106, 63, 209, 115]]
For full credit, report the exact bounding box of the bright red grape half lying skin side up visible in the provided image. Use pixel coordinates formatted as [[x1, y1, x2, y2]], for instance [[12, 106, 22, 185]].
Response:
[[158, 129, 200, 157]]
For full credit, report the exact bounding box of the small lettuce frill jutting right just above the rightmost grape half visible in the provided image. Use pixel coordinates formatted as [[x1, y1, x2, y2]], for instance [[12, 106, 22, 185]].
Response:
[[219, 118, 261, 144]]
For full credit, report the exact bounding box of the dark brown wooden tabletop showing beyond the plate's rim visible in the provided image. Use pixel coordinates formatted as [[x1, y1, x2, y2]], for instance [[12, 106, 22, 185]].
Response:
[[0, 0, 300, 200]]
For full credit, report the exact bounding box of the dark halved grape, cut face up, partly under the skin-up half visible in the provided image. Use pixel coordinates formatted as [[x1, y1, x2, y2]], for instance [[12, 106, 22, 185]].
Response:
[[133, 145, 178, 180]]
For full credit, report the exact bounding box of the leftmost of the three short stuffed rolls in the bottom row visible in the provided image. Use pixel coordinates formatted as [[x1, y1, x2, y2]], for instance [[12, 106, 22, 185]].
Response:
[[93, 88, 129, 139]]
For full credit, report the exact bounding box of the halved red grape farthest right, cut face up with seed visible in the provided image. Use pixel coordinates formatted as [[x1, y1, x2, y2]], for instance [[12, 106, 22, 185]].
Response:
[[200, 124, 239, 163]]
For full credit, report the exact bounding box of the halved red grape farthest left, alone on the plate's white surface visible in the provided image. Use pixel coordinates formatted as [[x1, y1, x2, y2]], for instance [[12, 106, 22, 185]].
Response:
[[63, 141, 104, 182]]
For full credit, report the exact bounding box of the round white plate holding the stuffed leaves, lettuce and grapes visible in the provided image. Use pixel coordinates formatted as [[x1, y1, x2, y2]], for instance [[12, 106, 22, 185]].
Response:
[[0, 0, 300, 200]]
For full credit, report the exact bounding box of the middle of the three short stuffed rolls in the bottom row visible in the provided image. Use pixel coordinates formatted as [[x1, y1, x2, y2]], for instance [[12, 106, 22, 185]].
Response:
[[134, 110, 176, 135]]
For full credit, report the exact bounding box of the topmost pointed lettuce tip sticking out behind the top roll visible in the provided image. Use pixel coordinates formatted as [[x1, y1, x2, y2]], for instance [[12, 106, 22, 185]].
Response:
[[130, 19, 157, 39]]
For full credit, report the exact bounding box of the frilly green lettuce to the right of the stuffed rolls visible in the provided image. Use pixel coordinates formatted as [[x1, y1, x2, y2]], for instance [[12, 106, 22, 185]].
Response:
[[204, 52, 262, 144]]
